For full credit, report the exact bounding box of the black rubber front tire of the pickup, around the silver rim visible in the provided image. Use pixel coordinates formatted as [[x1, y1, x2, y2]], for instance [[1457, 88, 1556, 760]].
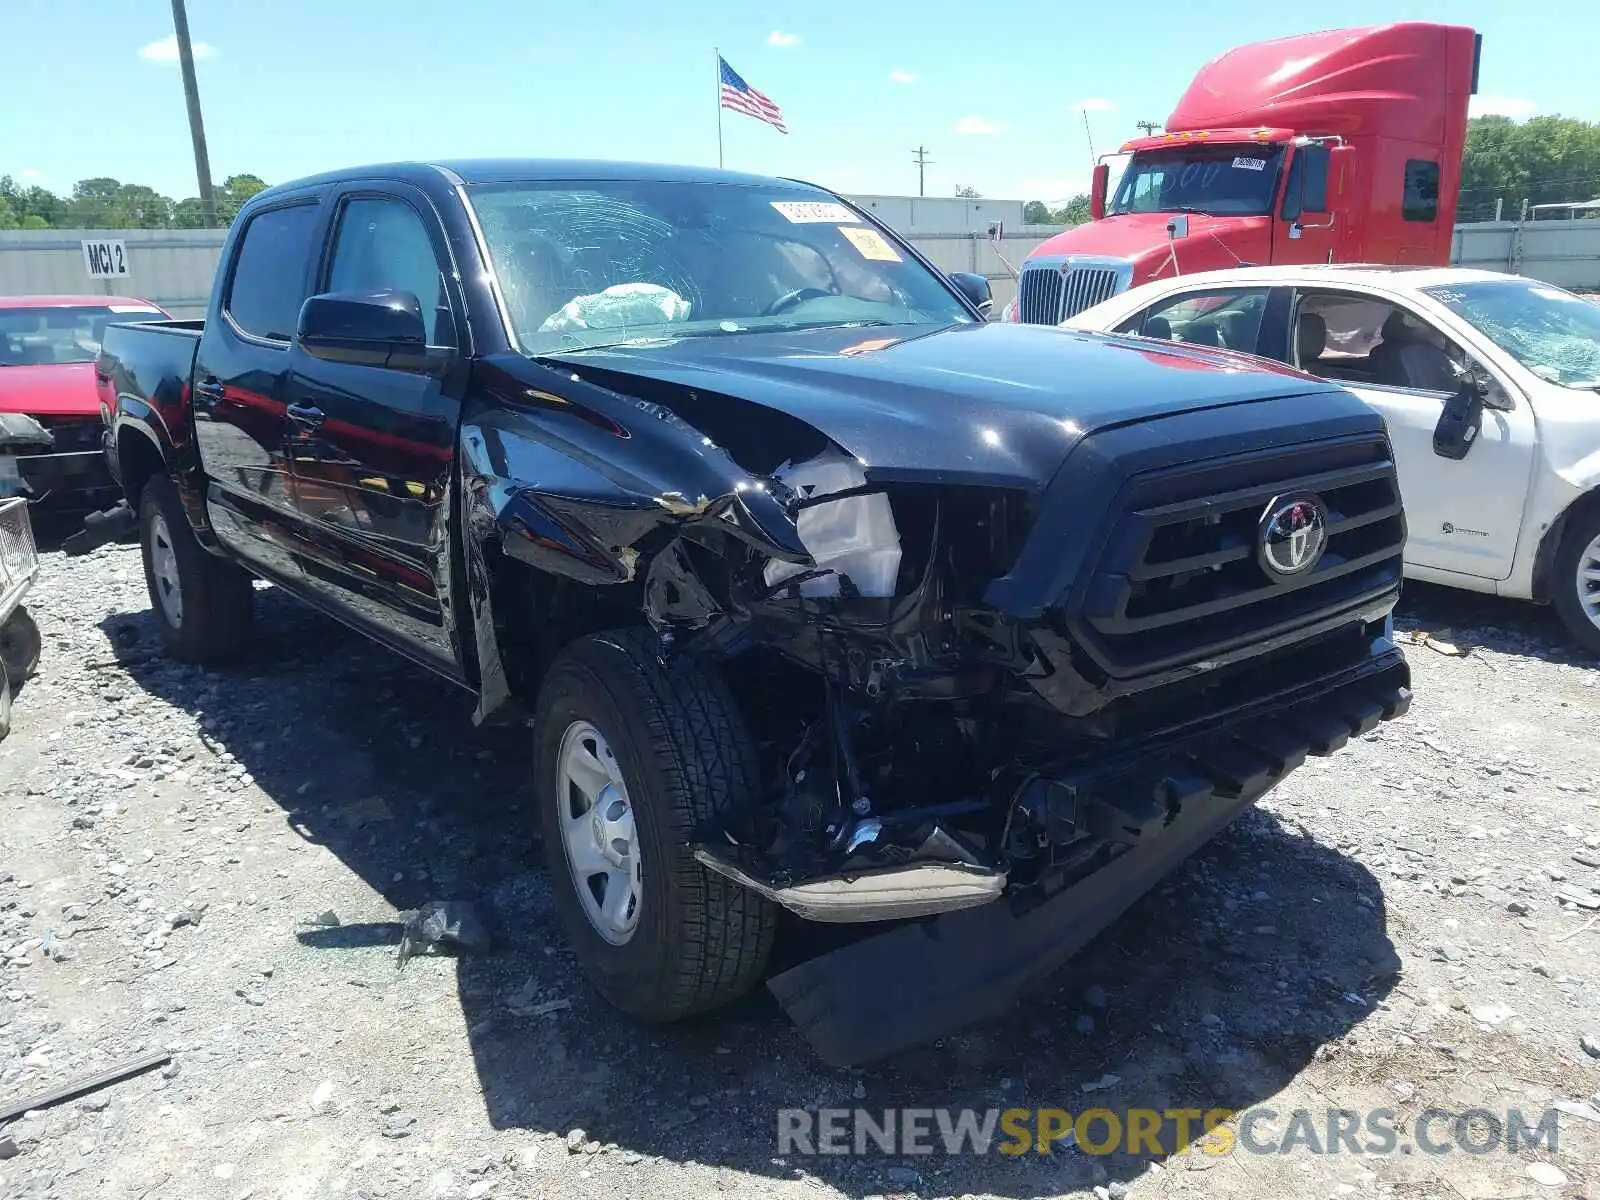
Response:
[[533, 629, 778, 1022]]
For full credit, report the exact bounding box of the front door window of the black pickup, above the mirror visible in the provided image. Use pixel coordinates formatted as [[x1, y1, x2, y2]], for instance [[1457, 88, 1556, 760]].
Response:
[[328, 197, 456, 346]]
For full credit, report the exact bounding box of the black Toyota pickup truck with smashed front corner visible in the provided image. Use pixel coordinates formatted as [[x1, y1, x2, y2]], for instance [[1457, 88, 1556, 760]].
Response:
[[98, 162, 1410, 1062]]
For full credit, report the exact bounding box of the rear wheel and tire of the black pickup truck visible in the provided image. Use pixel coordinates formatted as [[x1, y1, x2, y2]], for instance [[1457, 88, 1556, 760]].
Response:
[[139, 475, 254, 666]]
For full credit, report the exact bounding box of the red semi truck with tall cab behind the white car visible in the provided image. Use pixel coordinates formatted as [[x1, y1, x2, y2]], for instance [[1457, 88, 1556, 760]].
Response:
[[1005, 21, 1482, 325]]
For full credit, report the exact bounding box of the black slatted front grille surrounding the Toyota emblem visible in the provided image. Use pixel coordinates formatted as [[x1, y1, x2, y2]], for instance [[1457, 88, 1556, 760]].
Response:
[[1082, 437, 1405, 675]]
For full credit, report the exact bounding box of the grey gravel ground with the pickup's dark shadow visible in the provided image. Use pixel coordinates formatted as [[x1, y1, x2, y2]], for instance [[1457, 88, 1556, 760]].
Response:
[[0, 534, 1600, 1200]]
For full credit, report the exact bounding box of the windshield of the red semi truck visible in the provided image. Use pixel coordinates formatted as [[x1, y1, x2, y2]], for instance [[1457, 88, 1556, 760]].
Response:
[[1107, 144, 1283, 216]]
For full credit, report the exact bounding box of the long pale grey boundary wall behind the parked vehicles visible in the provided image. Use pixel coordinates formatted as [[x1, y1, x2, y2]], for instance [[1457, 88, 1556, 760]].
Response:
[[0, 213, 1600, 317]]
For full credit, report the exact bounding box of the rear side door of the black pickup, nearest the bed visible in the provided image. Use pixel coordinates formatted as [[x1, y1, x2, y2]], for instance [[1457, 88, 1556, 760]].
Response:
[[192, 195, 322, 584]]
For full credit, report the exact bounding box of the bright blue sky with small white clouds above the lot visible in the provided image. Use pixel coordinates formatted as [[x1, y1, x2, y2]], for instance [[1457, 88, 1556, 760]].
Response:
[[0, 0, 1600, 200]]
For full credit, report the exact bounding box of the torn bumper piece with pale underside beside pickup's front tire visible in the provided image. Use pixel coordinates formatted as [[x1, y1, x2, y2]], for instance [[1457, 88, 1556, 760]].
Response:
[[694, 850, 1005, 922]]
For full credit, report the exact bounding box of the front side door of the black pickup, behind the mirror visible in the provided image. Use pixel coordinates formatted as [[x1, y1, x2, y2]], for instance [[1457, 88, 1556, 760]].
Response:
[[285, 184, 466, 678]]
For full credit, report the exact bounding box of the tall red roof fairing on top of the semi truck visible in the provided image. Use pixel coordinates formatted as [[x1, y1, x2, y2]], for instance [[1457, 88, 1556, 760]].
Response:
[[1166, 21, 1478, 142]]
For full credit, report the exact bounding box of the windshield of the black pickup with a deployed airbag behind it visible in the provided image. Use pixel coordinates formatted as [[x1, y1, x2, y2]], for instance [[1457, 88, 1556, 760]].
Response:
[[470, 182, 973, 354]]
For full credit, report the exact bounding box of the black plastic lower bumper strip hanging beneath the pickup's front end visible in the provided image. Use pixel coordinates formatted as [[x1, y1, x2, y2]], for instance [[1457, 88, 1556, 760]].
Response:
[[768, 653, 1411, 1066]]
